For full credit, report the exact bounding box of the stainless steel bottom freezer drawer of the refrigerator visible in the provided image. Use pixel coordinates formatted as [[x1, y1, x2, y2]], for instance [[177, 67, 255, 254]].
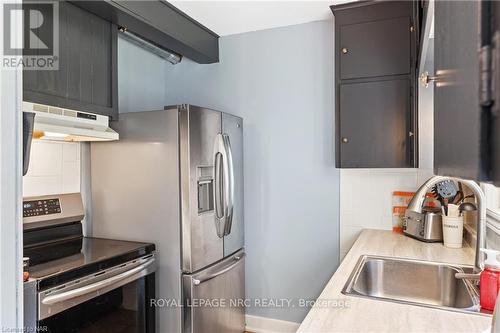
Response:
[[182, 250, 245, 333]]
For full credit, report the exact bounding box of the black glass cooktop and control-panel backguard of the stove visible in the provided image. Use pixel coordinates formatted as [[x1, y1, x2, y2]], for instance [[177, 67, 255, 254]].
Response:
[[23, 193, 155, 290]]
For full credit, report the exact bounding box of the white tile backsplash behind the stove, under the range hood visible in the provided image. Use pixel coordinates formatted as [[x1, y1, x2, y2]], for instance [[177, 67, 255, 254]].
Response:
[[23, 140, 81, 197]]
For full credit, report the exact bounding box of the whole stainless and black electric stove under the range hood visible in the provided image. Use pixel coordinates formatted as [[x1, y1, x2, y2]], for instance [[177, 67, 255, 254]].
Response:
[[23, 193, 156, 332]]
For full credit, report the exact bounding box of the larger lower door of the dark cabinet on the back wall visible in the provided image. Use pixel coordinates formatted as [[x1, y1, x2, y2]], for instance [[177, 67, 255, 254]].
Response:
[[338, 79, 412, 168]]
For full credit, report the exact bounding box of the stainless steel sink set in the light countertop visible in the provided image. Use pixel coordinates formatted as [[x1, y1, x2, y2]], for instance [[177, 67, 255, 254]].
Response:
[[342, 256, 488, 314]]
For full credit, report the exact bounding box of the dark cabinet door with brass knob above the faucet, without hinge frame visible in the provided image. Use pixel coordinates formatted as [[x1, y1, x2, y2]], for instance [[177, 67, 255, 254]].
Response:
[[434, 1, 488, 180]]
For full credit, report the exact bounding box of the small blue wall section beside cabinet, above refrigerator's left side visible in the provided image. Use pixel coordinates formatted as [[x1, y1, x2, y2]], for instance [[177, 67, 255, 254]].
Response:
[[118, 37, 170, 113]]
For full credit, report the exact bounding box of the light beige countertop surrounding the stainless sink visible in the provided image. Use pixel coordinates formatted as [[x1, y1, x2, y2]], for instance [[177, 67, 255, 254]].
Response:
[[297, 229, 491, 333]]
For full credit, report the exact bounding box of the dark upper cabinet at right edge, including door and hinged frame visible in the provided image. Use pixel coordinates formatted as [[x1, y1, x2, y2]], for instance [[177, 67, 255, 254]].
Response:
[[433, 1, 500, 186]]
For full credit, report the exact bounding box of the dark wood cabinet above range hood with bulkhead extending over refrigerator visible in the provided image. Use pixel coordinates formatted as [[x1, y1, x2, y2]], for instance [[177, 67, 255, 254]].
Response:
[[23, 0, 219, 120]]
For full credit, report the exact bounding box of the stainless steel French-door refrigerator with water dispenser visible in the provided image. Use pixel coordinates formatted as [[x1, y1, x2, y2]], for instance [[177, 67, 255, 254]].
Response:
[[90, 105, 245, 333]]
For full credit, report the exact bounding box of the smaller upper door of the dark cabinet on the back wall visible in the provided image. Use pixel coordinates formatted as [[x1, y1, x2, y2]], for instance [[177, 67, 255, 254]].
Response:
[[337, 16, 411, 79]]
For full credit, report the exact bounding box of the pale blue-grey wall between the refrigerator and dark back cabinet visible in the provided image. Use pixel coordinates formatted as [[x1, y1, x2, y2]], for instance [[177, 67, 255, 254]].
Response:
[[166, 21, 339, 322]]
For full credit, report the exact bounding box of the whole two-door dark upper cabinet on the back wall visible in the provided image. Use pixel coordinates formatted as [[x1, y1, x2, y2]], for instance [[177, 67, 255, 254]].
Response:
[[331, 1, 418, 168]]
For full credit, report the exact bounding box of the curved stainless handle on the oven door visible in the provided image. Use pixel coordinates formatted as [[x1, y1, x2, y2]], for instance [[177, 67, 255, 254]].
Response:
[[42, 258, 155, 305]]
